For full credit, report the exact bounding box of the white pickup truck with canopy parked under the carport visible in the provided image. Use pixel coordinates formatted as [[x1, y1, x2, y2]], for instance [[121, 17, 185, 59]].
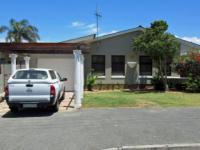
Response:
[[5, 69, 67, 112]]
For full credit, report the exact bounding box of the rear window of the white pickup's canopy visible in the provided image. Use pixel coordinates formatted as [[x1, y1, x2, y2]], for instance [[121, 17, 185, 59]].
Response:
[[13, 70, 48, 79]]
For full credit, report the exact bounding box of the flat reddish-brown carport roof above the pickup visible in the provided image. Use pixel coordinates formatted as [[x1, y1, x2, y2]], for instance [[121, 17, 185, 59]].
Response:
[[0, 43, 88, 54]]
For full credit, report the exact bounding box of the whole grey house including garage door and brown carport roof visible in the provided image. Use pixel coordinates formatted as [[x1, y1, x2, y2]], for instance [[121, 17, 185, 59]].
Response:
[[0, 26, 200, 91]]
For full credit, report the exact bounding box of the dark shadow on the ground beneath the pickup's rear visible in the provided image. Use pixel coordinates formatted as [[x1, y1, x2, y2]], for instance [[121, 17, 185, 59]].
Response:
[[2, 109, 54, 118]]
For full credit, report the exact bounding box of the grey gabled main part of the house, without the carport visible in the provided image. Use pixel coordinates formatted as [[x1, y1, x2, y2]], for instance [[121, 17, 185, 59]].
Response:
[[63, 26, 200, 87]]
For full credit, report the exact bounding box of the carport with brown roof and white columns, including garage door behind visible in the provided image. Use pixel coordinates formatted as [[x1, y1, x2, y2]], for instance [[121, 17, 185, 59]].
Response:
[[0, 43, 88, 108]]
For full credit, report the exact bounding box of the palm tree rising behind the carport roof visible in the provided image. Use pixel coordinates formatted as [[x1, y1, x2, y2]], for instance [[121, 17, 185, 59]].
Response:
[[6, 19, 40, 43]]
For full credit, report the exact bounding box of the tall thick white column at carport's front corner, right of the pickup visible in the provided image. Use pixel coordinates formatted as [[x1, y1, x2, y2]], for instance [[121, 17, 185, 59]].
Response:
[[74, 50, 82, 109]]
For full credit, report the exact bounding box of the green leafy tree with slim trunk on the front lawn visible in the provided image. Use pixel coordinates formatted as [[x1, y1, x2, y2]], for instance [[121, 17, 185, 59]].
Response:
[[133, 20, 180, 90]]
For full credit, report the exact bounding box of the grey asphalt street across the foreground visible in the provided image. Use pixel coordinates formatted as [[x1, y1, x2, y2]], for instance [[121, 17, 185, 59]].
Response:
[[0, 108, 200, 150]]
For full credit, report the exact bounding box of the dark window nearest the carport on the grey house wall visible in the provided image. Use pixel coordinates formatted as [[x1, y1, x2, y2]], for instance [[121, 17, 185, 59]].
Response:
[[92, 55, 105, 76]]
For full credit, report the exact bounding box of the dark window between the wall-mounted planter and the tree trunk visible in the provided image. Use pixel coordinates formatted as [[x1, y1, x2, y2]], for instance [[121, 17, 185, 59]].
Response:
[[140, 56, 152, 76]]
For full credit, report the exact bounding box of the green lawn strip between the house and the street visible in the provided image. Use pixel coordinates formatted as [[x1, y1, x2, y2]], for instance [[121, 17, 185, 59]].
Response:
[[83, 91, 200, 108]]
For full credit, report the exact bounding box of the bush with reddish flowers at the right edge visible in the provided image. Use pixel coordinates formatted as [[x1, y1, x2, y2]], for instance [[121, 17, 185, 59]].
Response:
[[176, 51, 200, 92]]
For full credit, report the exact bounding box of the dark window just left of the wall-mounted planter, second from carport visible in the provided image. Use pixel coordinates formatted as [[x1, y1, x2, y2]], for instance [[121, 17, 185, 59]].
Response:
[[112, 55, 125, 75]]
